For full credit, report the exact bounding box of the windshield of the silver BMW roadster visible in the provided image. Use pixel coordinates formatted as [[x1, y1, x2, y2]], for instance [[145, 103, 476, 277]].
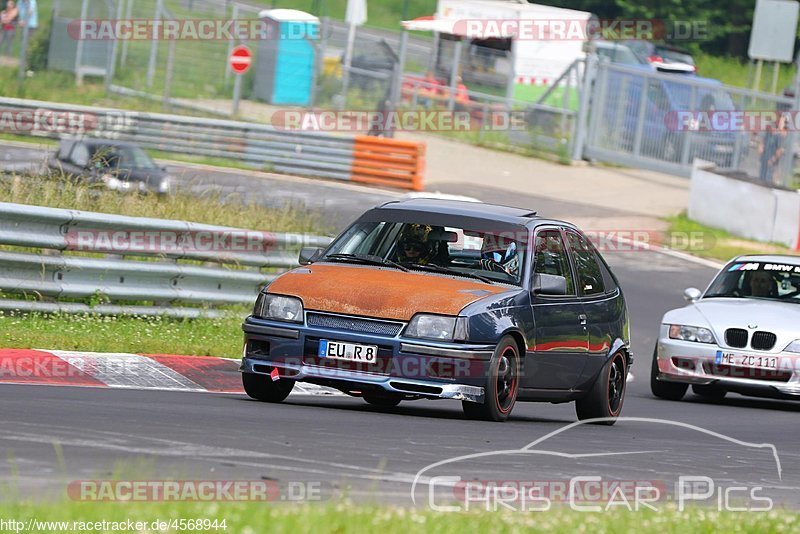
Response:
[[703, 262, 800, 303]]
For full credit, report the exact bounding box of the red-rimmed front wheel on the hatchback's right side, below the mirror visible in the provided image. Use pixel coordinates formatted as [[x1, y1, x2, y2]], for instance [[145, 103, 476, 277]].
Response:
[[461, 336, 520, 422]]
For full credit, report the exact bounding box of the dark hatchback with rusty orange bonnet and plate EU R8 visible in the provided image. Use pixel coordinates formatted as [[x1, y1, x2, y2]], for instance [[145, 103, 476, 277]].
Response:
[[241, 198, 632, 424]]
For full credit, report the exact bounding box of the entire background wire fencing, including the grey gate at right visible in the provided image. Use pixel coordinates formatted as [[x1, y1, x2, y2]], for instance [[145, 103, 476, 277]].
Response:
[[40, 0, 798, 187]]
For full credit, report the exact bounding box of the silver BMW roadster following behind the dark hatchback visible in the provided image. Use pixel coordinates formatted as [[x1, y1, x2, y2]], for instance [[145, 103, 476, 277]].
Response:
[[650, 255, 800, 400]]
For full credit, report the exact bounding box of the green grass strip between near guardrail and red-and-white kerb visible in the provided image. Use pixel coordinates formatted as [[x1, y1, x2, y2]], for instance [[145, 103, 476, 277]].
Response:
[[0, 308, 247, 358]]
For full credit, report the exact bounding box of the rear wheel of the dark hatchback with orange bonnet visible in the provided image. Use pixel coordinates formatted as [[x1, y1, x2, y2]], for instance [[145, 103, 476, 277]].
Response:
[[575, 352, 628, 425]]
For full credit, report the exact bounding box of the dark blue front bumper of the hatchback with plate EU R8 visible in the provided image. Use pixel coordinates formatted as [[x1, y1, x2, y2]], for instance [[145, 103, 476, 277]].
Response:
[[240, 317, 495, 402]]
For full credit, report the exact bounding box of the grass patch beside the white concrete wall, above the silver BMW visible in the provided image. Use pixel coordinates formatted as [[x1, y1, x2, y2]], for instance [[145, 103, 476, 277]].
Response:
[[666, 213, 792, 261]]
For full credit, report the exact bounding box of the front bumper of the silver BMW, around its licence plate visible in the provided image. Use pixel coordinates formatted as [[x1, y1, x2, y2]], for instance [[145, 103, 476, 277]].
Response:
[[656, 337, 800, 397]]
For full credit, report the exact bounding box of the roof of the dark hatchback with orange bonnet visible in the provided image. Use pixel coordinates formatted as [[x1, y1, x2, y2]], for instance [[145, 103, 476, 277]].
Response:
[[375, 197, 575, 228]]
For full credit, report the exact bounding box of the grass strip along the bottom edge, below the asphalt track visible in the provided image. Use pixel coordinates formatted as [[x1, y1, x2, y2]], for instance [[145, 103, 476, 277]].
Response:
[[0, 502, 798, 534]]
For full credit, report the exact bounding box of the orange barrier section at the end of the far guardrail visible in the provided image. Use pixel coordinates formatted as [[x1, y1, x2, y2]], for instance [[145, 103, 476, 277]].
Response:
[[350, 135, 425, 191]]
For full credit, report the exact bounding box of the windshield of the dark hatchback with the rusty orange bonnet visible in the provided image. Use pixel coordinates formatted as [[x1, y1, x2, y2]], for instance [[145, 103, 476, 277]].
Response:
[[320, 221, 527, 286]]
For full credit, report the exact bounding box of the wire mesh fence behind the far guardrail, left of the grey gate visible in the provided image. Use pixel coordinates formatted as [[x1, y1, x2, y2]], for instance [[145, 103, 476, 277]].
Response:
[[43, 0, 577, 158]]
